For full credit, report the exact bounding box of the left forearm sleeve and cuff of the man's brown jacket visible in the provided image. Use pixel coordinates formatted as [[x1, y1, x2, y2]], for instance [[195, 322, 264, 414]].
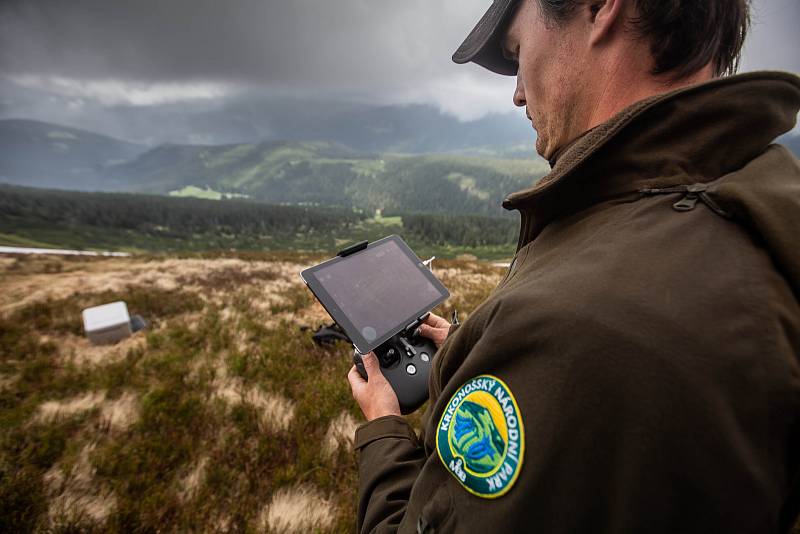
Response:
[[355, 415, 426, 533]]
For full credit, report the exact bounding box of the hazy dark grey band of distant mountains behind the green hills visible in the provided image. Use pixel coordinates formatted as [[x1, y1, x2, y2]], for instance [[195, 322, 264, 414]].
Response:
[[0, 80, 536, 157]]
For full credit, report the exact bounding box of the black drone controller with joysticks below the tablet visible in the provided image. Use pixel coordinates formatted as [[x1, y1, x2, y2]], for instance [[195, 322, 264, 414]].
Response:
[[353, 314, 436, 414]]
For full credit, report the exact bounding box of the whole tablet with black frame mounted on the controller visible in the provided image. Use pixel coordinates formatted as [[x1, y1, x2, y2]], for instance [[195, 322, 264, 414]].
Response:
[[300, 235, 450, 354]]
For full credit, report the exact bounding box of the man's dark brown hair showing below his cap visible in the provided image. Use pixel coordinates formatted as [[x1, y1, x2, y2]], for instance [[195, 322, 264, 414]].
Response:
[[537, 0, 750, 79]]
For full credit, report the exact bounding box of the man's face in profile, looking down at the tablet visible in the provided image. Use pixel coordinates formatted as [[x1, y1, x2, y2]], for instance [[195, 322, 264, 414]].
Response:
[[504, 0, 586, 159]]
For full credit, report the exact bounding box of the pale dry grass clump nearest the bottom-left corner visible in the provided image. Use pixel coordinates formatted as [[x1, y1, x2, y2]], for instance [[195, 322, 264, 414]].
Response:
[[43, 444, 117, 528]]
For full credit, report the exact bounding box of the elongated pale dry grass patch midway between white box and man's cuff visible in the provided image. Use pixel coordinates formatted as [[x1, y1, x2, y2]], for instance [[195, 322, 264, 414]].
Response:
[[211, 362, 295, 431]]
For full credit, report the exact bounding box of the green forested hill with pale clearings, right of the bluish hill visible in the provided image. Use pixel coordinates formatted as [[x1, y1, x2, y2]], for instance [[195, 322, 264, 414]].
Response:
[[107, 142, 548, 220]]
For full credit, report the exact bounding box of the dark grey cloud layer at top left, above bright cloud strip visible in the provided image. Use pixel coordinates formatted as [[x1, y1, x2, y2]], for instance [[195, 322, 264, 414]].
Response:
[[0, 0, 484, 88]]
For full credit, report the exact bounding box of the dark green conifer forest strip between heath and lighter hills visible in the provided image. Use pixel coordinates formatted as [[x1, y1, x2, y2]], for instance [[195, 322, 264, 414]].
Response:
[[0, 185, 518, 258]]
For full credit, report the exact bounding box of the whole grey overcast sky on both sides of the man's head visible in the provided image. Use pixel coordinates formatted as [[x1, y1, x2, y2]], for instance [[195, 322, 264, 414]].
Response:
[[0, 0, 800, 120]]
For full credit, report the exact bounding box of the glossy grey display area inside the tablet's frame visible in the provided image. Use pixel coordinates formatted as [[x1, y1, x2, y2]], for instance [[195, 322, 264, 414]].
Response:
[[315, 240, 441, 341]]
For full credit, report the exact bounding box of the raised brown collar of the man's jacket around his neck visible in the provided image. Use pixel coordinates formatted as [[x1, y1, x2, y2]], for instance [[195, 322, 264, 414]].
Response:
[[503, 72, 800, 246]]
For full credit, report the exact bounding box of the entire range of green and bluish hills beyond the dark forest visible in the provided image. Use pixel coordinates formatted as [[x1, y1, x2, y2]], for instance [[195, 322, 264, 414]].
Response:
[[0, 119, 800, 220]]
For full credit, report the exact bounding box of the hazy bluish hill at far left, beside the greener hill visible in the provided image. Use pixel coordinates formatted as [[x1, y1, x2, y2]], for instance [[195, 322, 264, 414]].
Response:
[[0, 119, 145, 189]]
